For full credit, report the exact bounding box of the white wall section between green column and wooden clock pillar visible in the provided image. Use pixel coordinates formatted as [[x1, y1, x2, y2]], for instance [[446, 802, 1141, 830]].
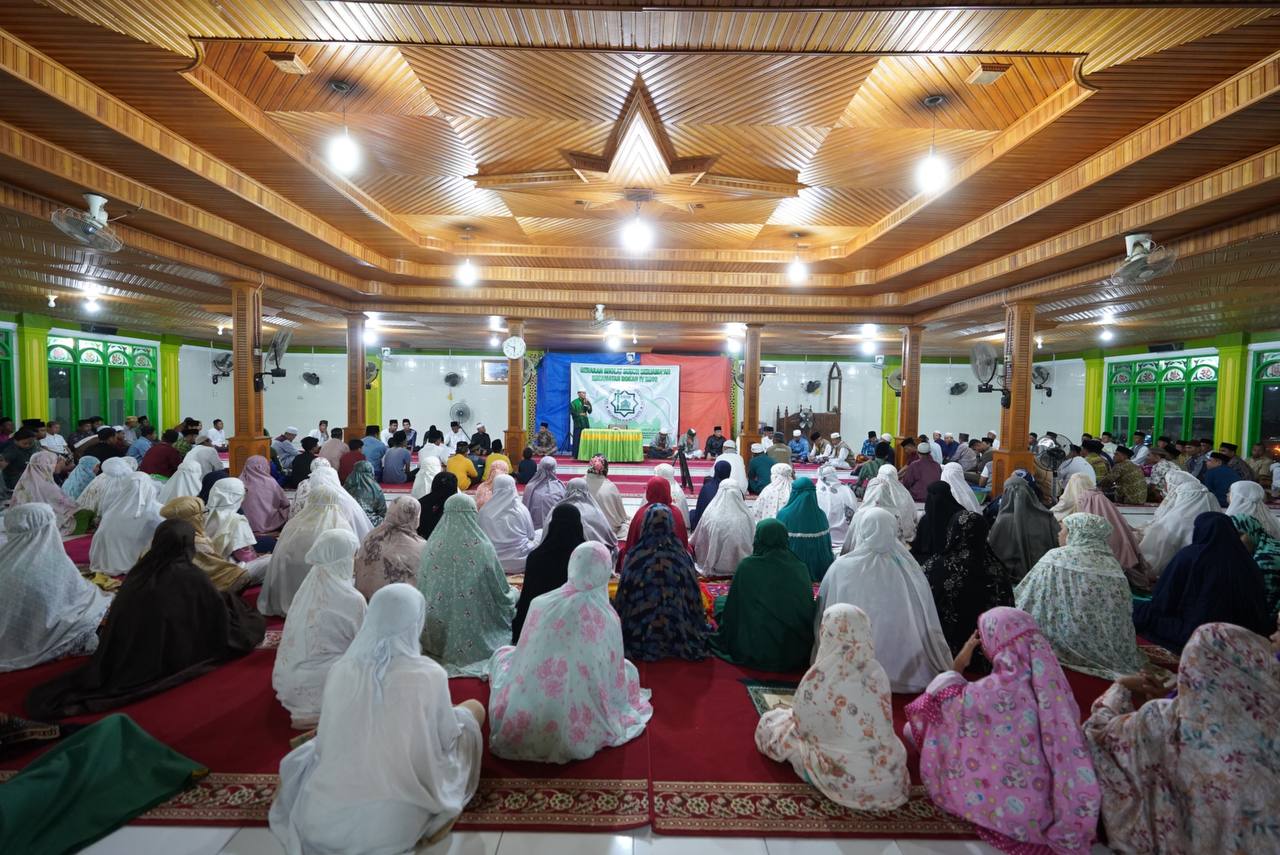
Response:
[[383, 353, 507, 439]]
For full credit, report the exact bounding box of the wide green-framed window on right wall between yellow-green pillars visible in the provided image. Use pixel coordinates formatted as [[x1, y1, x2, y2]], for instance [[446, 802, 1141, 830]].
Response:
[[1103, 356, 1217, 443]]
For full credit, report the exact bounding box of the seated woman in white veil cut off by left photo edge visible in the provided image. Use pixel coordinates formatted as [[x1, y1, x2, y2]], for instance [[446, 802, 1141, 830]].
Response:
[[0, 502, 111, 671]]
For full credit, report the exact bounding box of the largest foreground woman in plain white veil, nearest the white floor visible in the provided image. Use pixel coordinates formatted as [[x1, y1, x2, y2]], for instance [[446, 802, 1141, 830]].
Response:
[[269, 582, 484, 855]]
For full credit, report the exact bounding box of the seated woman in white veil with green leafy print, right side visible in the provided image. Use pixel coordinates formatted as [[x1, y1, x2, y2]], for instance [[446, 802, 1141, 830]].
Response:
[[1014, 513, 1147, 680]]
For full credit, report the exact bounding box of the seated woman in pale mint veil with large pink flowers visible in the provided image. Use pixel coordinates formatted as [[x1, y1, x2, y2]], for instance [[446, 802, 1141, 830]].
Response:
[[489, 540, 653, 763]]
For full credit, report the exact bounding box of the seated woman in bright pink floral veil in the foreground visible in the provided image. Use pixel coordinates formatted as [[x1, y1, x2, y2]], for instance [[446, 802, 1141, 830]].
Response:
[[906, 608, 1100, 855]]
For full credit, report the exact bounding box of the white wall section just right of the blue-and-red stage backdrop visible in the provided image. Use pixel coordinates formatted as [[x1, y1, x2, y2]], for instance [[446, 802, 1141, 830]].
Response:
[[760, 357, 883, 443]]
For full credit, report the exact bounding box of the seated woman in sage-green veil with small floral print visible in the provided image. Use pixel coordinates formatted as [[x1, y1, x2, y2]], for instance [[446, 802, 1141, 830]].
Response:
[[417, 493, 518, 677]]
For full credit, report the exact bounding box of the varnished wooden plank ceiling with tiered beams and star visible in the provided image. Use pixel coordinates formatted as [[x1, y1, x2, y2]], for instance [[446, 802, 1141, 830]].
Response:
[[0, 0, 1280, 353]]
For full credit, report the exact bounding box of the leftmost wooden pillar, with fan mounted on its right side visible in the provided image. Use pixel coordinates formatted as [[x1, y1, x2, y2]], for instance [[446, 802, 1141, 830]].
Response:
[[227, 282, 271, 475]]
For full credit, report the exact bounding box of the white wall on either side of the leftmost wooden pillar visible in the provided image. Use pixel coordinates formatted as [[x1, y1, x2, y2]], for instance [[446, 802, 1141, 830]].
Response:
[[178, 344, 347, 436]]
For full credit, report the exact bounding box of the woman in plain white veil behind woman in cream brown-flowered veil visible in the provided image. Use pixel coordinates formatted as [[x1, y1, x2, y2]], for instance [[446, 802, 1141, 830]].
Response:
[[814, 507, 952, 692]]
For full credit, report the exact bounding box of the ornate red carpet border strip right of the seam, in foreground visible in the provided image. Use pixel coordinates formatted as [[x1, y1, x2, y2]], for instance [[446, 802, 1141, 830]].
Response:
[[653, 781, 975, 838]]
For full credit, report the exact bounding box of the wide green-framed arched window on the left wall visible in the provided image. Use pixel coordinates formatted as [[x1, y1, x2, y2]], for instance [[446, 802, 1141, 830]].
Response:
[[47, 335, 160, 434]]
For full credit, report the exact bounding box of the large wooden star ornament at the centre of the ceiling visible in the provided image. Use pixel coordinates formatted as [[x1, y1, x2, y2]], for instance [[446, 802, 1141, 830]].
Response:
[[467, 76, 805, 212]]
